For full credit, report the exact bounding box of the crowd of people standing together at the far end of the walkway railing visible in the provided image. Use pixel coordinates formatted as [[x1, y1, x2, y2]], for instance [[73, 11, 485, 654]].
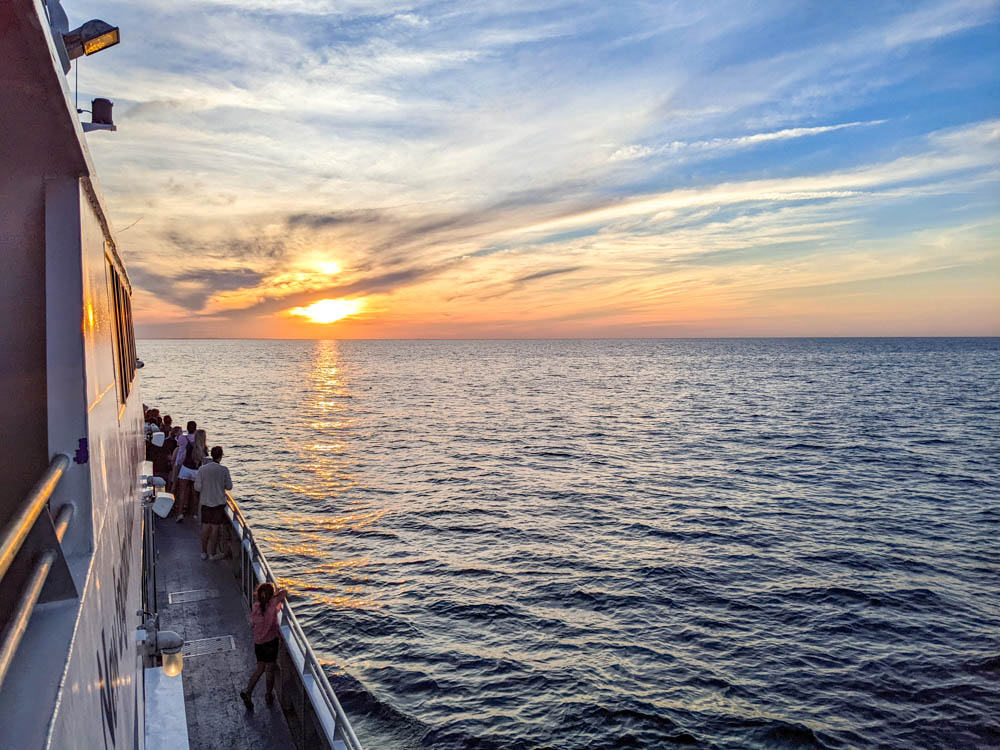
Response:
[[145, 408, 233, 560]]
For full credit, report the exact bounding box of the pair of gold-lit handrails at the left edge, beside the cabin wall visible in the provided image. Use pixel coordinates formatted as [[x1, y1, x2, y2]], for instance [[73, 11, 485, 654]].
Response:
[[0, 453, 73, 685]]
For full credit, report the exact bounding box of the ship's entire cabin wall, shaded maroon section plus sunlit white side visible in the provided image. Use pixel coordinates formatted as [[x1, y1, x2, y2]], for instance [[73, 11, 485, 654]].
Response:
[[0, 0, 143, 750]]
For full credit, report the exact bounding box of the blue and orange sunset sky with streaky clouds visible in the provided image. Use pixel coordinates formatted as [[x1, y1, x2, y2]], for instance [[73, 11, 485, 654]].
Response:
[[72, 0, 1000, 338]]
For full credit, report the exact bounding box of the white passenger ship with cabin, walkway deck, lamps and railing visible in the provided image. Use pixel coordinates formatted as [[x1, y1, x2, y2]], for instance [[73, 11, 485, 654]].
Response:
[[0, 0, 361, 750]]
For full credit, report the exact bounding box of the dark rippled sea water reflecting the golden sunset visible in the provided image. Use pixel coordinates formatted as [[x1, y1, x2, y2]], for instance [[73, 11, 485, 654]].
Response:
[[139, 339, 1000, 750]]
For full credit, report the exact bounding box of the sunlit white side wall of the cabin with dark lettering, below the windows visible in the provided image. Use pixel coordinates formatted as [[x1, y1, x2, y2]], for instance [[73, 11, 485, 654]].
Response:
[[48, 189, 144, 750]]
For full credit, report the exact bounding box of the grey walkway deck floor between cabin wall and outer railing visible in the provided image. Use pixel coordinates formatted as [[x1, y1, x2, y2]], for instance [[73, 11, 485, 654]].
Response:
[[155, 517, 295, 750]]
